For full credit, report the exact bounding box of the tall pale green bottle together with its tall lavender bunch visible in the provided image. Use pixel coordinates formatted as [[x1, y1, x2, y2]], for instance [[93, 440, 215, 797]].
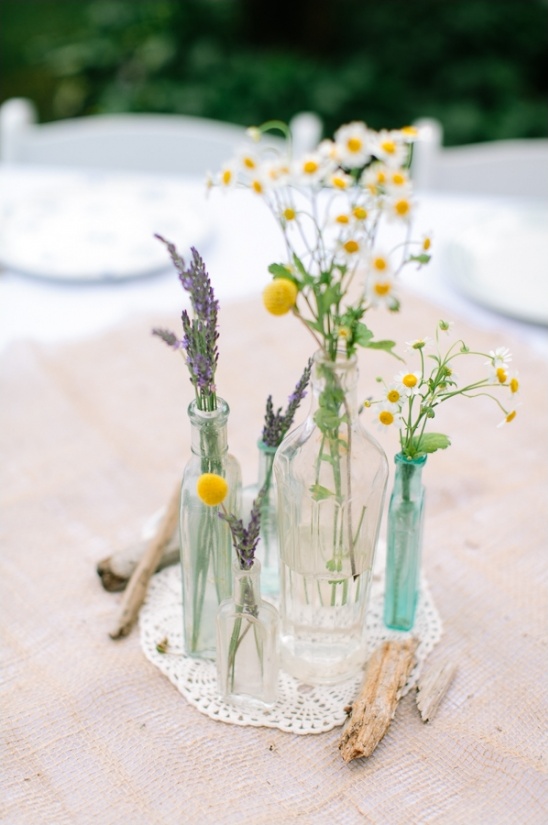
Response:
[[153, 236, 241, 658]]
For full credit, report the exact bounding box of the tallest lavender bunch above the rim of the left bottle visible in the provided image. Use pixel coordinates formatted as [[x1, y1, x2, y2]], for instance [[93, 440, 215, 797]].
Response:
[[152, 235, 219, 411]]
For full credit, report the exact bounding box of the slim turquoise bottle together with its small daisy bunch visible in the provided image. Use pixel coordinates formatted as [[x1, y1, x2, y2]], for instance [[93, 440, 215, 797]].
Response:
[[365, 321, 519, 630]]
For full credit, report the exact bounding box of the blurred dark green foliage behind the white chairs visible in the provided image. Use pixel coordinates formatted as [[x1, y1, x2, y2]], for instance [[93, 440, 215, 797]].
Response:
[[0, 0, 548, 145]]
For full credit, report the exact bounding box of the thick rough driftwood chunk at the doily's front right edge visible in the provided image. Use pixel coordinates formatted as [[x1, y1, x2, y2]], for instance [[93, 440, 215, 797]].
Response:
[[339, 638, 418, 762]]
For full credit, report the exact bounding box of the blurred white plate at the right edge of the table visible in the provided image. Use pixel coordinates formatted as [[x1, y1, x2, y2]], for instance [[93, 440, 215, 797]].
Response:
[[444, 202, 548, 324]]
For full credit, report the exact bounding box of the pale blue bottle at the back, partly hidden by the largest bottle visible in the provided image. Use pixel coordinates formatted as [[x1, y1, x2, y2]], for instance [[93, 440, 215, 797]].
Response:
[[242, 441, 280, 599]]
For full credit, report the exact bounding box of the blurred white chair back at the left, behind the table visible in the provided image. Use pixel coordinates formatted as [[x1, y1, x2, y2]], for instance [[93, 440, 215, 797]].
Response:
[[0, 98, 312, 175]]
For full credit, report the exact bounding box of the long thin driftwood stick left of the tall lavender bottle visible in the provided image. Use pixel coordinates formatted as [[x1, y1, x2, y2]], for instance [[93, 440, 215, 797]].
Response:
[[109, 484, 180, 639]]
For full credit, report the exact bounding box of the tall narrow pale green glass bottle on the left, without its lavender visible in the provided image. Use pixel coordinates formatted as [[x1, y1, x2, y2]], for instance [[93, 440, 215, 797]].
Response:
[[179, 398, 242, 659]]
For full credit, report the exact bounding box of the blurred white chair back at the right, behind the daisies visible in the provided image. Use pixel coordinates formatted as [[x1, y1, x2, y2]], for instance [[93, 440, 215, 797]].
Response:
[[411, 118, 548, 197]]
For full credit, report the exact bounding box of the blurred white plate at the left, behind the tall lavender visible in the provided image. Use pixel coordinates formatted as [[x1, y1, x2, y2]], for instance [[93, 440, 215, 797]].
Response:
[[0, 173, 209, 281]]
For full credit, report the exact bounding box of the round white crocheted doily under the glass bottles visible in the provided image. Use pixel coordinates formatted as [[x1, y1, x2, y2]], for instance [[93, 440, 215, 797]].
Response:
[[140, 565, 442, 734]]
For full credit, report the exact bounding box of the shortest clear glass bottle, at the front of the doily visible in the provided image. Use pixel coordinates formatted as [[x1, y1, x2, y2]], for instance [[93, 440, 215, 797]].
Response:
[[217, 560, 279, 710]]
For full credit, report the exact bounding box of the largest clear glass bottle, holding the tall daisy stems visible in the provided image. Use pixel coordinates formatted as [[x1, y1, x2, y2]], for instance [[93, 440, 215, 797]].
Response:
[[274, 353, 388, 684]]
